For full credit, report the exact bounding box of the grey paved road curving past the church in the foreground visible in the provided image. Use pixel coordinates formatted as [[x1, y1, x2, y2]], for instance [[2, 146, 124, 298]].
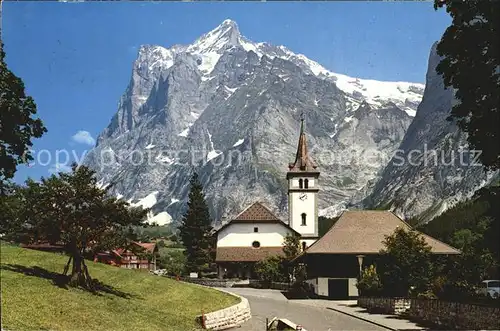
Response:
[[226, 288, 387, 331]]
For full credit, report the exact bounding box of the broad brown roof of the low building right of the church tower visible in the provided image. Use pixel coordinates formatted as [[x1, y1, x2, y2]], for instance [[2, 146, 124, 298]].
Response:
[[305, 210, 460, 255]]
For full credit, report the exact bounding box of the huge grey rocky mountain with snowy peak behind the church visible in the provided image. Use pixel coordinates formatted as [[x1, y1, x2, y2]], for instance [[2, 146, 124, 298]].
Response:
[[85, 20, 430, 223]]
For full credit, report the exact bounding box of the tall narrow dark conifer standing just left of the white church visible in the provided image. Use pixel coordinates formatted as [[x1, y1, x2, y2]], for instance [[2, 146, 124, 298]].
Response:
[[179, 173, 214, 272]]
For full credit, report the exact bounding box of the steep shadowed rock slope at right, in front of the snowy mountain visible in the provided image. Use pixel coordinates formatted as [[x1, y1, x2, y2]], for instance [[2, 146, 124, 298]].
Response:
[[363, 43, 497, 223]]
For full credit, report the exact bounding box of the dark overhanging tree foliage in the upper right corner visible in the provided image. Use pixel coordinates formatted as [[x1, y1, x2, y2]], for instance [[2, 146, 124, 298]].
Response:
[[435, 0, 500, 169]]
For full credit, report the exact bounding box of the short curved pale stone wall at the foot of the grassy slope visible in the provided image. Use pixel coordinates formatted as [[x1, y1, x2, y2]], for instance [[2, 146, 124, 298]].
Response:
[[198, 290, 252, 330]]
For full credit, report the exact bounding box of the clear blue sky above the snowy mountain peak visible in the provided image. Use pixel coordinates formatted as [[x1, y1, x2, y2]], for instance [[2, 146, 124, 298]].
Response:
[[2, 1, 451, 182]]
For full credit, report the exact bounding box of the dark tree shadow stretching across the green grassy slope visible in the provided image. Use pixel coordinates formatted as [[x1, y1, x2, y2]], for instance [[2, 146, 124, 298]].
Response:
[[0, 264, 137, 299]]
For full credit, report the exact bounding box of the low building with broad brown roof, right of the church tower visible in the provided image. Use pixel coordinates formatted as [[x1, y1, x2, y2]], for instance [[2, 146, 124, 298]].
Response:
[[296, 210, 460, 299]]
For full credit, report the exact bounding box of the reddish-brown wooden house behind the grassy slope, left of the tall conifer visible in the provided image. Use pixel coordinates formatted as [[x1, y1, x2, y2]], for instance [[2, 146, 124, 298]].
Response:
[[94, 242, 158, 270]]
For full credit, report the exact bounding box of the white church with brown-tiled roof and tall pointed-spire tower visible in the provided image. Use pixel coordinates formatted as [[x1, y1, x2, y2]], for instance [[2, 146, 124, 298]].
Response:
[[216, 118, 320, 278]]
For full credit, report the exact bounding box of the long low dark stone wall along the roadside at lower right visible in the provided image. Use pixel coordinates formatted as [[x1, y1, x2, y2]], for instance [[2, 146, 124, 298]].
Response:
[[358, 298, 500, 330]]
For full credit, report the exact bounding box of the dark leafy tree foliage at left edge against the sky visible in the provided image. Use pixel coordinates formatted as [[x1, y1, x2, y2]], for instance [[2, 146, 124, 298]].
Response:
[[0, 42, 47, 194]]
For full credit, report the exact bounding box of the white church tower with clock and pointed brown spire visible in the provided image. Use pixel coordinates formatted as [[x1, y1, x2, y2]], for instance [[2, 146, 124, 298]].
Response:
[[286, 117, 319, 247]]
